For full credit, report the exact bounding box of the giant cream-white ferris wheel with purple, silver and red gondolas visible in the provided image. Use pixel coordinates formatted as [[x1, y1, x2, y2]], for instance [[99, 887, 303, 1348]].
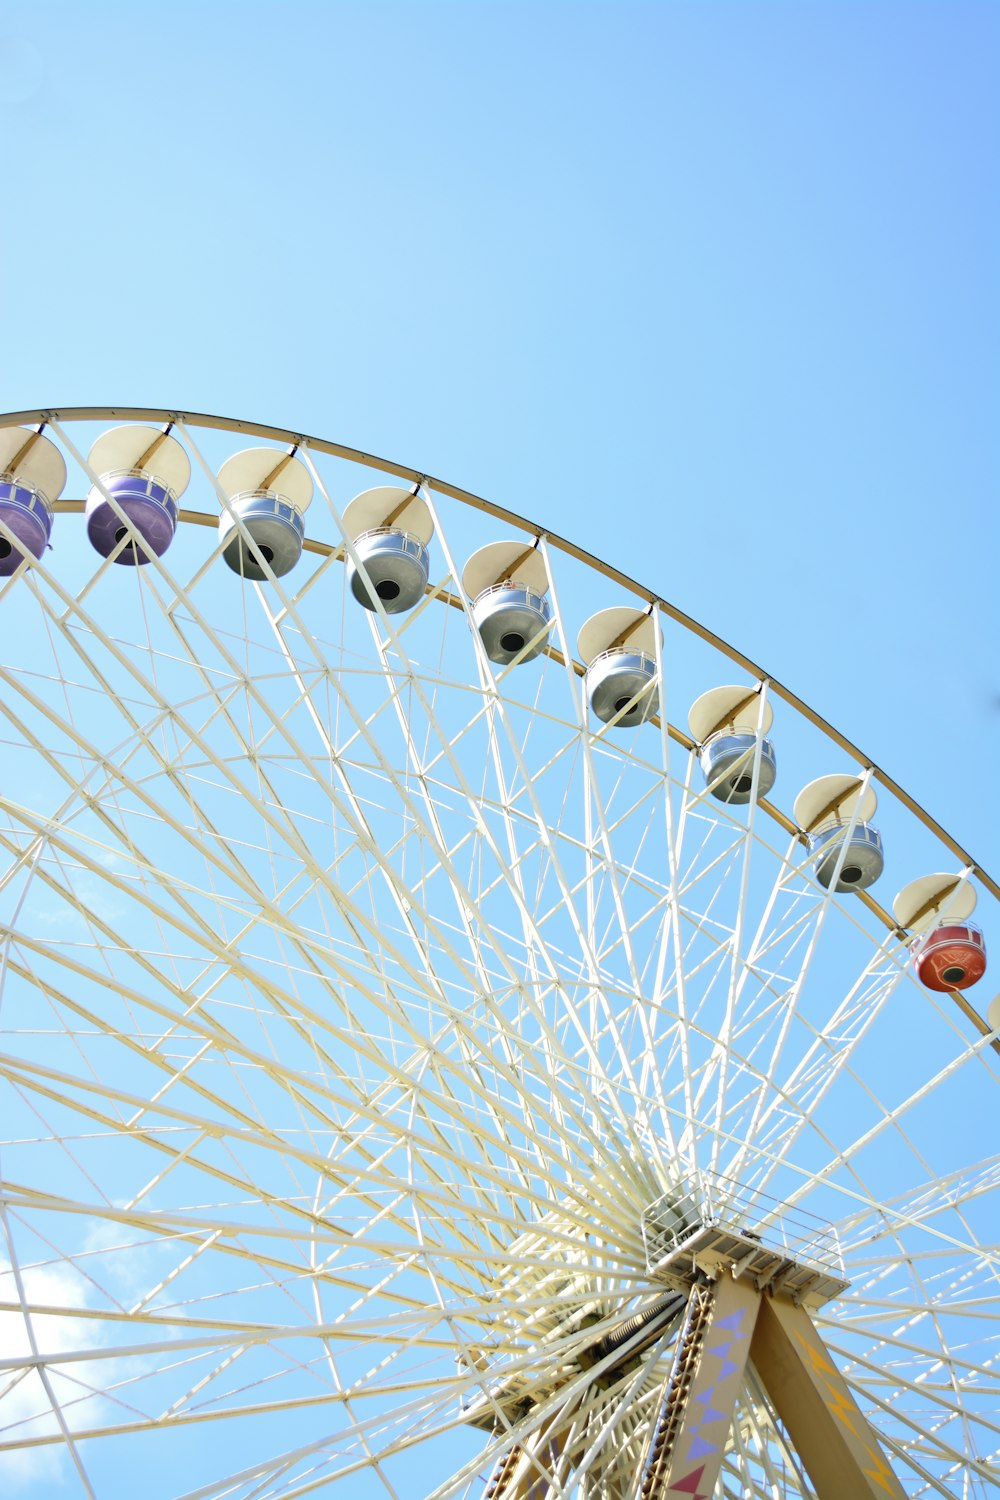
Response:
[[0, 408, 1000, 1500]]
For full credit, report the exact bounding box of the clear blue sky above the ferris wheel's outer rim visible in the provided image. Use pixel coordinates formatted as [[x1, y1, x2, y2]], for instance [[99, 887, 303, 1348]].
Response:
[[0, 0, 1000, 870]]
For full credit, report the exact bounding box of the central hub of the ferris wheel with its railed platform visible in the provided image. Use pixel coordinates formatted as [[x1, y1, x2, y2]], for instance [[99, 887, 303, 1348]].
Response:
[[463, 1173, 849, 1430]]
